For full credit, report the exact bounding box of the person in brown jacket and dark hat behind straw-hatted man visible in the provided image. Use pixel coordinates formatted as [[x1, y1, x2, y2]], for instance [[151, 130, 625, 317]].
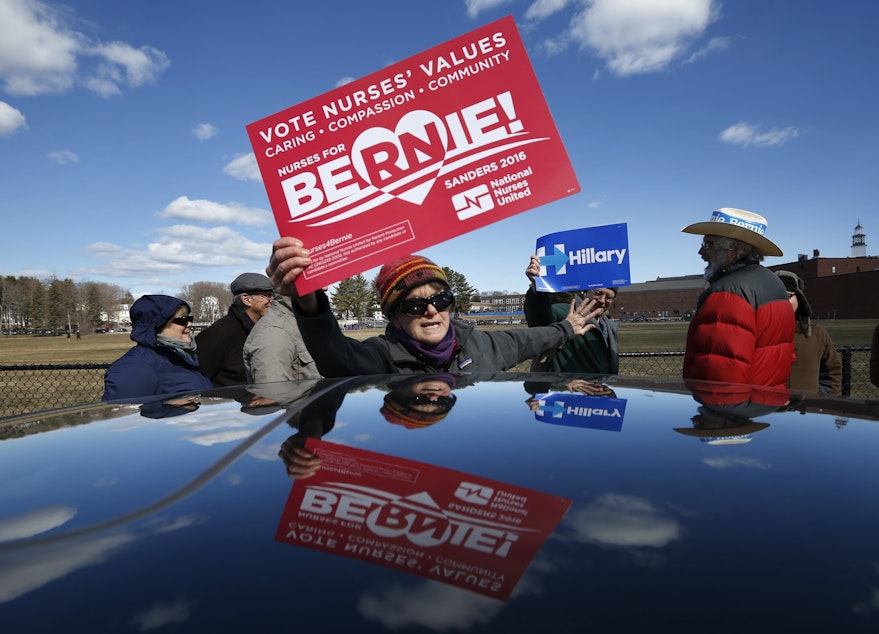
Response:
[[776, 271, 842, 394]]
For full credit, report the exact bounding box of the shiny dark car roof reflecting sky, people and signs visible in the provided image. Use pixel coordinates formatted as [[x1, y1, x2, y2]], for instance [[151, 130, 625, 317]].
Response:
[[0, 374, 879, 633]]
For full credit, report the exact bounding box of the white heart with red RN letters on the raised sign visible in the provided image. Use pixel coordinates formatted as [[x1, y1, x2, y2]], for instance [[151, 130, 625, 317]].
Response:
[[351, 110, 449, 205]]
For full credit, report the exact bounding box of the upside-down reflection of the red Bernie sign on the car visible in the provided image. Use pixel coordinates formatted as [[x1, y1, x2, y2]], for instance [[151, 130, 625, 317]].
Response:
[[275, 439, 571, 601]]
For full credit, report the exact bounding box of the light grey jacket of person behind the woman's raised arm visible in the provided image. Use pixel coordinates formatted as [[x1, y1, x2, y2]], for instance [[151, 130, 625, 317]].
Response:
[[243, 297, 321, 383]]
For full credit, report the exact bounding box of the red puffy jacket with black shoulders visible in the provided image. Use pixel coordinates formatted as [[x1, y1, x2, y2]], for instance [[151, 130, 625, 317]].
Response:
[[684, 264, 796, 387]]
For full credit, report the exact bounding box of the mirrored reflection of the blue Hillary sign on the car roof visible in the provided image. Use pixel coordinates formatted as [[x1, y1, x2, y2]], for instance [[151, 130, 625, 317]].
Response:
[[534, 392, 626, 431]]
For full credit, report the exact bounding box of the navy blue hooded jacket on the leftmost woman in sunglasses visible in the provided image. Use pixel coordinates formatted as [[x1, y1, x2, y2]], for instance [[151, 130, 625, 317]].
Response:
[[101, 295, 212, 401]]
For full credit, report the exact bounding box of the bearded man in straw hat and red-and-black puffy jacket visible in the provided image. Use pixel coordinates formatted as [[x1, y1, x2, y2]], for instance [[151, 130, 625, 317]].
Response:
[[682, 207, 795, 387]]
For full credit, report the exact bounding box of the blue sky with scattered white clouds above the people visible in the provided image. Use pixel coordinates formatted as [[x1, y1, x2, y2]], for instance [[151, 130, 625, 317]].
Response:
[[0, 0, 879, 296]]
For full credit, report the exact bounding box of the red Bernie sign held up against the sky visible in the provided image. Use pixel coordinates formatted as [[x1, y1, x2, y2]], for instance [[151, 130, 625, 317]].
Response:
[[247, 16, 580, 293]]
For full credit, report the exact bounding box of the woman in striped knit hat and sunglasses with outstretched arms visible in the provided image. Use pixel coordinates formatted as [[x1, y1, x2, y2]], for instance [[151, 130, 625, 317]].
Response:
[[266, 237, 598, 377]]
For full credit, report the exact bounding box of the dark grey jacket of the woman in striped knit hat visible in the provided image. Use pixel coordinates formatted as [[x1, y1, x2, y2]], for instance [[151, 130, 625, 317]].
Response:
[[292, 292, 576, 377]]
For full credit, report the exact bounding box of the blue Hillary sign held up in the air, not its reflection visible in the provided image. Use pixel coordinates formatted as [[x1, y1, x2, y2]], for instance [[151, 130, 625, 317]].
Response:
[[535, 223, 632, 293]]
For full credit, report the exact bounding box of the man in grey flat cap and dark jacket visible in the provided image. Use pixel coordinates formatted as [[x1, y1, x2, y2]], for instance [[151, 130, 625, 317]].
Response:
[[195, 273, 275, 387]]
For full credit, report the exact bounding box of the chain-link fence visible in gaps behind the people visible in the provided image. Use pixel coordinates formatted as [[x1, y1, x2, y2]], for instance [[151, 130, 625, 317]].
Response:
[[0, 346, 879, 418]]
